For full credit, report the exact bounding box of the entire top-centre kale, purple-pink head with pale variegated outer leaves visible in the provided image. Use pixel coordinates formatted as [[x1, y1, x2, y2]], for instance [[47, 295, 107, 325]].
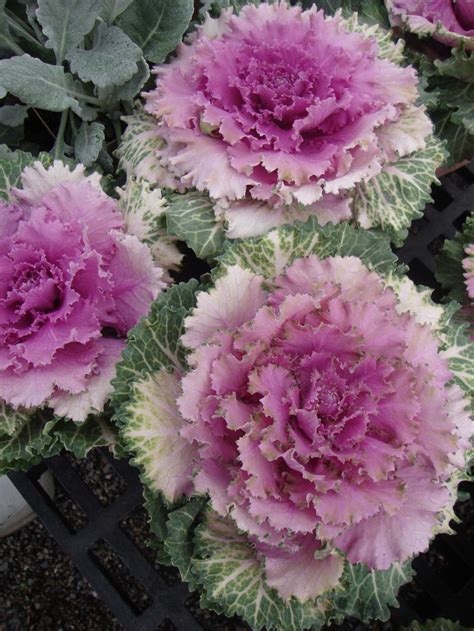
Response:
[[119, 2, 445, 256]]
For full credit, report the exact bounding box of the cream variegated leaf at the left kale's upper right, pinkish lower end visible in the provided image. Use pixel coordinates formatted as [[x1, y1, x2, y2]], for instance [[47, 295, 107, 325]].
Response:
[[118, 177, 183, 270]]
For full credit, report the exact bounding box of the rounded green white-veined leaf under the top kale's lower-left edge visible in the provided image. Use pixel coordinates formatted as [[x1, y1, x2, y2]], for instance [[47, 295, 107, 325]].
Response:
[[166, 191, 224, 259]]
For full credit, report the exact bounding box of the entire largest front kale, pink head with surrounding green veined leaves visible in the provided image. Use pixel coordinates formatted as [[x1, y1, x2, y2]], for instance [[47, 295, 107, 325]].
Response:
[[113, 219, 474, 631]]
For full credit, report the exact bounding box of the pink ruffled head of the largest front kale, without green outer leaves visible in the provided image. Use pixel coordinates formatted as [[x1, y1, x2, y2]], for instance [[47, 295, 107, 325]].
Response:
[[176, 256, 472, 601]]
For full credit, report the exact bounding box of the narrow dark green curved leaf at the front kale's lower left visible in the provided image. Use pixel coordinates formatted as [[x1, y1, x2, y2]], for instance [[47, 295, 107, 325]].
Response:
[[164, 498, 206, 590]]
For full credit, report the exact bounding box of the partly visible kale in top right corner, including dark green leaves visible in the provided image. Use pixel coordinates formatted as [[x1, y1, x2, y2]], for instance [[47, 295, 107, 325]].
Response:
[[385, 0, 474, 166]]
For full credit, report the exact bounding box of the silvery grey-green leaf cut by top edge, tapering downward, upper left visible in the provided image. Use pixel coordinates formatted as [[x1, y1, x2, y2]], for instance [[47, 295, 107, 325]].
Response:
[[36, 0, 101, 63]]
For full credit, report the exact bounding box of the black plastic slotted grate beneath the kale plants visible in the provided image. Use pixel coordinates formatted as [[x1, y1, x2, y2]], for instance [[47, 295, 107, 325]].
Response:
[[6, 165, 474, 631]]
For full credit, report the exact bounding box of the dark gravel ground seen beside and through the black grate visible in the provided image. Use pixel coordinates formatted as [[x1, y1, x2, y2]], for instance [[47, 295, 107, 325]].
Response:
[[0, 452, 474, 631]]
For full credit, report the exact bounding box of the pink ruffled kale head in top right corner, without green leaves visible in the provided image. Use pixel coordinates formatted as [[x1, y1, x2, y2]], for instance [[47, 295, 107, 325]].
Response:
[[385, 0, 474, 50]]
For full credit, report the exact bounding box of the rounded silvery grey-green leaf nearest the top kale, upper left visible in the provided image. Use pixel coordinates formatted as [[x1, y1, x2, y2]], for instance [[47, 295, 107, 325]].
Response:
[[66, 24, 142, 88]]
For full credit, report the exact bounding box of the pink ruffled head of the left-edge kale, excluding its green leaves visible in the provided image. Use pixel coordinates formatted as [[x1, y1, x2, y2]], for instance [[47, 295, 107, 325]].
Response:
[[0, 162, 164, 421]]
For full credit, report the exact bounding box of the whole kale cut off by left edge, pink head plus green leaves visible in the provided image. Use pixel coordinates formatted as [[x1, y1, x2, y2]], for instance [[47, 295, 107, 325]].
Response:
[[0, 152, 181, 470]]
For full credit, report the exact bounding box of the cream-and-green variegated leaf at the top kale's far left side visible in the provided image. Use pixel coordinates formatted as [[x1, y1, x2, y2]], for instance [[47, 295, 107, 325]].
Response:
[[116, 112, 165, 183]]
